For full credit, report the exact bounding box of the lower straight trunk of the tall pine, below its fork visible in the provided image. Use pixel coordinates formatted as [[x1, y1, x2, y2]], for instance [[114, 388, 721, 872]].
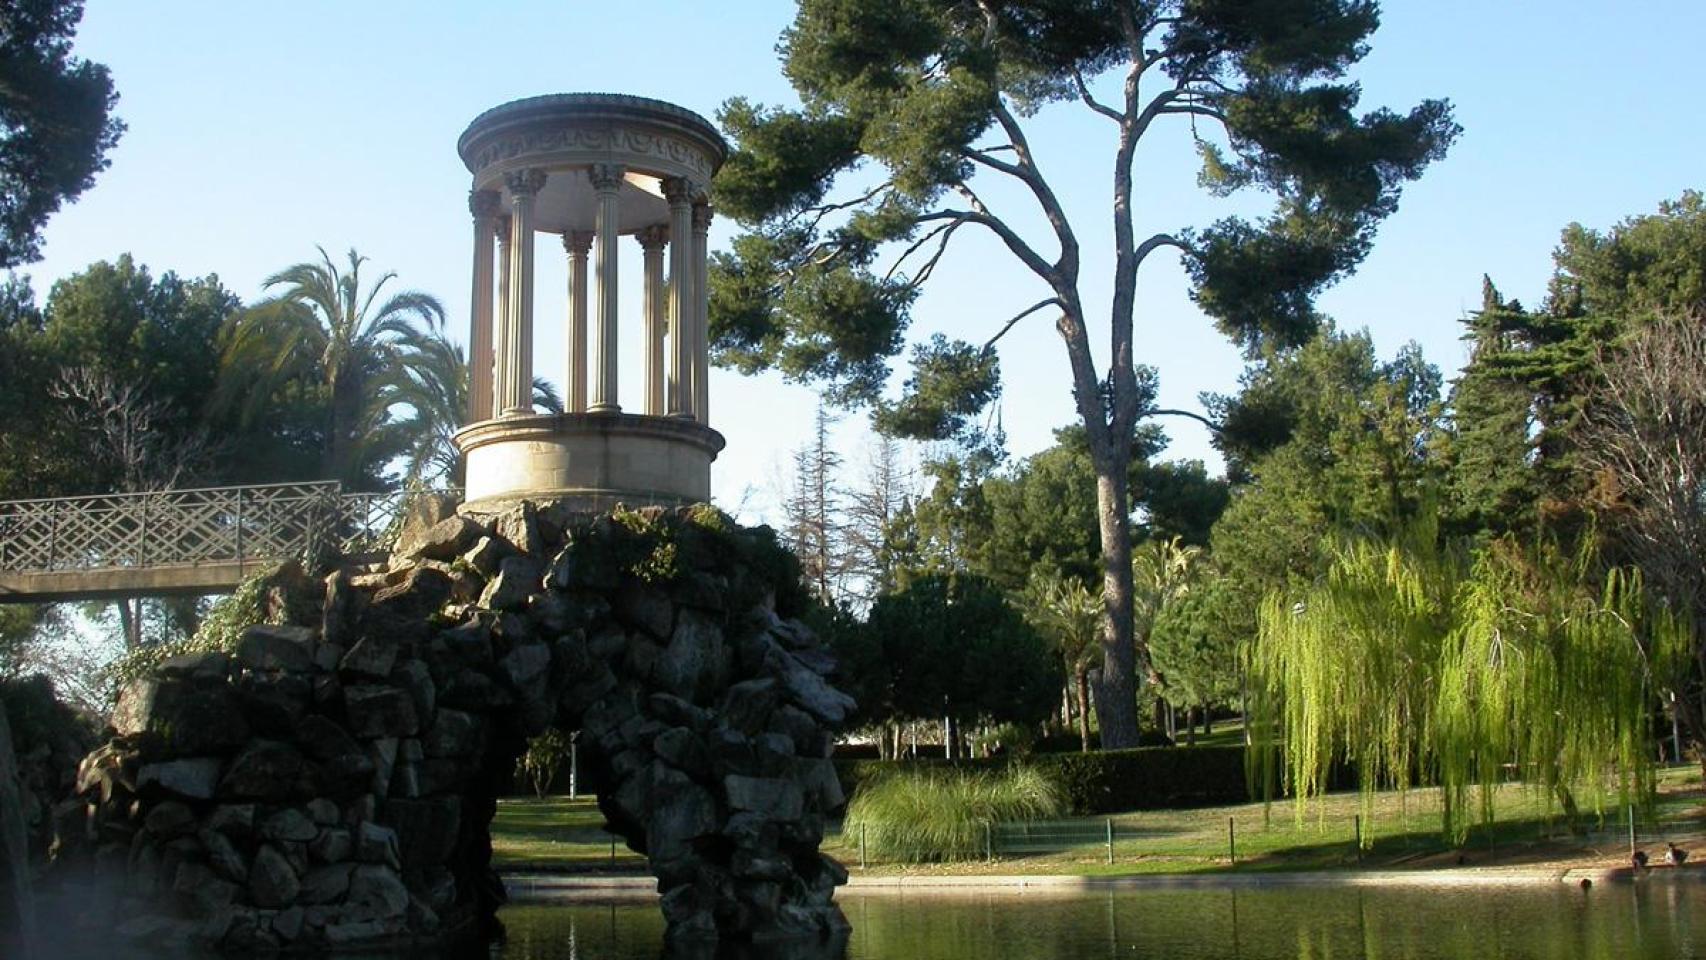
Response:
[[1092, 467, 1138, 750]]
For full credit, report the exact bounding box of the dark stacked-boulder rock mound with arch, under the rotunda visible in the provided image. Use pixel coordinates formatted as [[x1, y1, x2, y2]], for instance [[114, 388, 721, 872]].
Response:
[[61, 503, 853, 953]]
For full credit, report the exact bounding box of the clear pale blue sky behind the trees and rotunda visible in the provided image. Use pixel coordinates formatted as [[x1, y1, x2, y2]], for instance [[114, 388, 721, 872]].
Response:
[[26, 0, 1706, 517]]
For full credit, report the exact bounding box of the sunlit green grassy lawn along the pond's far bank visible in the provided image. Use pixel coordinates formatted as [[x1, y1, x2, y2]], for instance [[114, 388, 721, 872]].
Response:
[[491, 767, 1706, 876]]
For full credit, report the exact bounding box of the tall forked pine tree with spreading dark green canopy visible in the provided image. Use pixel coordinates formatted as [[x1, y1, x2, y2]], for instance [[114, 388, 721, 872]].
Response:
[[710, 0, 1457, 747]]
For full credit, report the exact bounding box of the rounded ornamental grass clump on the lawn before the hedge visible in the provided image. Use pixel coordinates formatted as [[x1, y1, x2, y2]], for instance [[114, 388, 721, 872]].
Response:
[[843, 767, 1066, 863]]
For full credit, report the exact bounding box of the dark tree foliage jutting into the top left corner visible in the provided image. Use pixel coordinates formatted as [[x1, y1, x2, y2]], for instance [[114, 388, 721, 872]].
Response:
[[0, 0, 125, 269]]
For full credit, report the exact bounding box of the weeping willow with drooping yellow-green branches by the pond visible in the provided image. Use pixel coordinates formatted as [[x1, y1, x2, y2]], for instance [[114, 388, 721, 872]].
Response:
[[1249, 523, 1682, 842]]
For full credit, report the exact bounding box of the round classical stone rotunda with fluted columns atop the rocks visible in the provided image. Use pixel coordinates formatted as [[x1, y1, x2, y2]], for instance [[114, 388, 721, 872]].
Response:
[[456, 94, 728, 512]]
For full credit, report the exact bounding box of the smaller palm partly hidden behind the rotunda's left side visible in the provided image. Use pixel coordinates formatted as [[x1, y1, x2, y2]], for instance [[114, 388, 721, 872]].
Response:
[[379, 329, 563, 488]]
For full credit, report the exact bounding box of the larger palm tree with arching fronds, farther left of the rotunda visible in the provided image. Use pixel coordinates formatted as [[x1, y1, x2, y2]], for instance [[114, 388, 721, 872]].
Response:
[[220, 247, 444, 484]]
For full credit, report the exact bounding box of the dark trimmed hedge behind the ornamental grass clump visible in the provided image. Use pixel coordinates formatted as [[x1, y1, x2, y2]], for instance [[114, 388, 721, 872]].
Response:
[[836, 747, 1250, 813]]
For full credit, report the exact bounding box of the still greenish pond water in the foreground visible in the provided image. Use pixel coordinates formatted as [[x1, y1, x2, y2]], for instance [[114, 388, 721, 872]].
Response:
[[493, 882, 1706, 960]]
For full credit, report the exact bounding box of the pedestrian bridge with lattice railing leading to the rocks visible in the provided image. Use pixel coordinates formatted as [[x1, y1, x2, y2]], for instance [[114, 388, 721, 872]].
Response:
[[0, 483, 433, 604]]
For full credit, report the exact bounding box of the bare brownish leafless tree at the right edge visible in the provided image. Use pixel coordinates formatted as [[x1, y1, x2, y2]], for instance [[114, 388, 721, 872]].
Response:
[[1581, 314, 1706, 777]]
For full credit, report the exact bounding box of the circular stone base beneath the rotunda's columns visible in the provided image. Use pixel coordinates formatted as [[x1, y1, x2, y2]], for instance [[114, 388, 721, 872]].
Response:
[[454, 413, 723, 512]]
